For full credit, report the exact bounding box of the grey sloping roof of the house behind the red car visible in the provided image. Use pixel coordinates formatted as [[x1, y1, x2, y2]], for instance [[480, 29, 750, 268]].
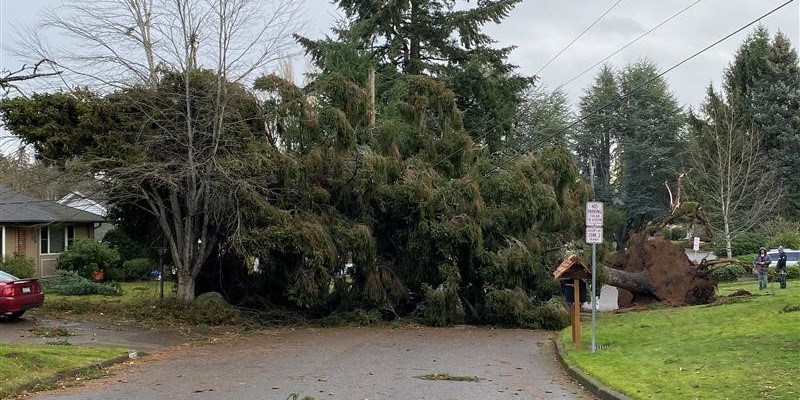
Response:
[[0, 185, 105, 223]]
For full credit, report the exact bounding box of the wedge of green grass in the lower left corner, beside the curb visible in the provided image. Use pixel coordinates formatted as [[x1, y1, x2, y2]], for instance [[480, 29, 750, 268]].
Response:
[[0, 343, 127, 398]]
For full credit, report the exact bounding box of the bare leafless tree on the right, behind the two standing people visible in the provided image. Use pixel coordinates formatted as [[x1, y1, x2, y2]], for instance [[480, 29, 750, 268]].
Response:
[[689, 106, 782, 258]]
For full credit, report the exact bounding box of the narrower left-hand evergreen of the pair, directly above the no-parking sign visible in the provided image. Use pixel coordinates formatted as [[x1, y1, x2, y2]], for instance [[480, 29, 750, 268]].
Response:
[[571, 66, 620, 202]]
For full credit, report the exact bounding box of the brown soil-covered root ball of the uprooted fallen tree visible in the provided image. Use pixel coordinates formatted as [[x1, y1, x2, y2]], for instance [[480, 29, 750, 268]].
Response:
[[609, 234, 716, 304]]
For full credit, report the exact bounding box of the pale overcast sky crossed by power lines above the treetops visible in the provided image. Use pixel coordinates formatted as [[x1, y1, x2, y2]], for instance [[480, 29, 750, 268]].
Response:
[[0, 0, 800, 106]]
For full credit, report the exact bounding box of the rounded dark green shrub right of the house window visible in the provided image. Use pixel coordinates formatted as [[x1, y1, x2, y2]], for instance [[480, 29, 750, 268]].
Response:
[[56, 238, 119, 279]]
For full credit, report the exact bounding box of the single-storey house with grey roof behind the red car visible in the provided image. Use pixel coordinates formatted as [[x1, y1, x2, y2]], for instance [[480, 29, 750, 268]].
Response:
[[0, 185, 105, 277]]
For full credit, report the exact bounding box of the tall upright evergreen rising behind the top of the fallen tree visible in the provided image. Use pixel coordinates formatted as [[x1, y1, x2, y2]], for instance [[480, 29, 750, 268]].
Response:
[[322, 0, 533, 151]]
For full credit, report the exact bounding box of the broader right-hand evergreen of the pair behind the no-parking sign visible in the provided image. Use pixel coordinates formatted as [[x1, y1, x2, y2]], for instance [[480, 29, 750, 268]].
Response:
[[617, 61, 685, 228]]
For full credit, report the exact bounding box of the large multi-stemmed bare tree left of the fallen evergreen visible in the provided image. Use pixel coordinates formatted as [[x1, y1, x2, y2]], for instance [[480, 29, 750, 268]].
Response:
[[14, 0, 302, 299]]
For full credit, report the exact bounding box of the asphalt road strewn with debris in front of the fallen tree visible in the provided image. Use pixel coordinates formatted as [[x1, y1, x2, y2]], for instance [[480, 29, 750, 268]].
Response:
[[23, 327, 593, 400]]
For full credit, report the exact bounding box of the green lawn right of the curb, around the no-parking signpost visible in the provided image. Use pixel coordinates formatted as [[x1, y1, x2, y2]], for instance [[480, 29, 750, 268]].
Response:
[[561, 280, 800, 400]]
